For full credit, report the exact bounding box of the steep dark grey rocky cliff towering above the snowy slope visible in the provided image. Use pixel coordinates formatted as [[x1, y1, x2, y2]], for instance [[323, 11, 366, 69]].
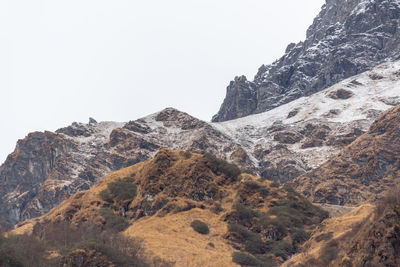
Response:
[[212, 0, 400, 122]]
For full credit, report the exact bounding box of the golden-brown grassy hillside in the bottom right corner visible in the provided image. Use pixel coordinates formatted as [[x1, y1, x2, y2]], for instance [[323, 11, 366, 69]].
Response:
[[283, 188, 400, 267]]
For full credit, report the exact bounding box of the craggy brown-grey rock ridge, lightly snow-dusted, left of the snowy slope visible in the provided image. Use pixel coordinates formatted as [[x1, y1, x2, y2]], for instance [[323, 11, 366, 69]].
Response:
[[0, 111, 239, 224]]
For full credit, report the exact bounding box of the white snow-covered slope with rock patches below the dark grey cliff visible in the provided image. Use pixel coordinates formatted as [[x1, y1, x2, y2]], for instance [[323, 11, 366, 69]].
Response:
[[212, 61, 400, 182]]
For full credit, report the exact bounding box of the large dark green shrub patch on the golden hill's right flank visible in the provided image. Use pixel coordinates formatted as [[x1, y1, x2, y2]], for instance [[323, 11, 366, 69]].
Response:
[[228, 185, 328, 266]]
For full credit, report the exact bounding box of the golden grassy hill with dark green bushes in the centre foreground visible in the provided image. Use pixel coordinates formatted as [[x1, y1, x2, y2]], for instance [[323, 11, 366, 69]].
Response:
[[12, 149, 327, 266]]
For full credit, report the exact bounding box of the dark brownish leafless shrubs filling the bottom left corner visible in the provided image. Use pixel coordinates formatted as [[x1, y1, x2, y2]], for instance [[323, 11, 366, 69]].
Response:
[[0, 223, 171, 267]]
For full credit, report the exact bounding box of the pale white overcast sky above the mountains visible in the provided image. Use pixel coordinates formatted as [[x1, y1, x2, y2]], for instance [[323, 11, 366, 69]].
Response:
[[0, 0, 324, 163]]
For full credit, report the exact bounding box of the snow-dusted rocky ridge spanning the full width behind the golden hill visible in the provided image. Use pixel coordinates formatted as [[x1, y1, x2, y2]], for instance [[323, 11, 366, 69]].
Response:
[[0, 61, 400, 224]]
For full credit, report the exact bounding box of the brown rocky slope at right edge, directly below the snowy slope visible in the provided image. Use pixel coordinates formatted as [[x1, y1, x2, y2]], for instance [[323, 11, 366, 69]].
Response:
[[290, 105, 400, 205]]
